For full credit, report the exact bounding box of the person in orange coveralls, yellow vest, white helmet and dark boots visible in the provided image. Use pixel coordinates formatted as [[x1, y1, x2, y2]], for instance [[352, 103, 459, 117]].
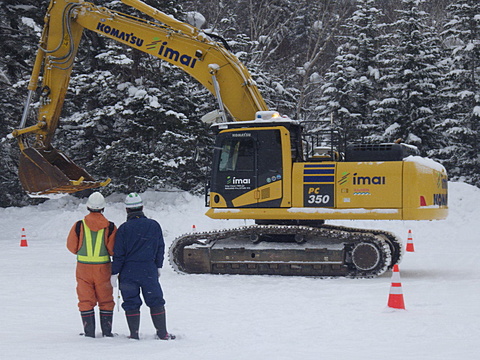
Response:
[[67, 192, 117, 338]]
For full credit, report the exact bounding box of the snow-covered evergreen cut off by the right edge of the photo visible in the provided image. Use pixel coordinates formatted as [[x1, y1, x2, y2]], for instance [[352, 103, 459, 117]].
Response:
[[433, 0, 480, 186]]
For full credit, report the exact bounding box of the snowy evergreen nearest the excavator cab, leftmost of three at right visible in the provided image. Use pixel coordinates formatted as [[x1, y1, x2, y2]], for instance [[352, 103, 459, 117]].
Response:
[[321, 0, 382, 142]]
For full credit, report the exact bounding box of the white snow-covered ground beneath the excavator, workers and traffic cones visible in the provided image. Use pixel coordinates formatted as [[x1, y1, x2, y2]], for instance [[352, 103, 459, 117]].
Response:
[[0, 183, 480, 360]]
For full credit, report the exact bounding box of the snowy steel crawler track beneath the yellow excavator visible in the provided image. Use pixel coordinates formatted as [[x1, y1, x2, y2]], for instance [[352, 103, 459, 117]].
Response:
[[169, 225, 402, 278]]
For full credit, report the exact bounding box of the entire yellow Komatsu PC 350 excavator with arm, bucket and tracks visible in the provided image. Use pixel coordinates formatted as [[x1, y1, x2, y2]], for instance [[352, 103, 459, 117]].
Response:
[[12, 0, 448, 278]]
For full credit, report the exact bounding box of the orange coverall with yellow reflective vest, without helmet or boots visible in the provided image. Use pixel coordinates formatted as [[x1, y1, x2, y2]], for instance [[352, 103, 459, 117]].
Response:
[[67, 212, 117, 311]]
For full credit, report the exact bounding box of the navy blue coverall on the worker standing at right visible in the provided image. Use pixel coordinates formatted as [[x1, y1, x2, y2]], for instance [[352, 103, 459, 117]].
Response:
[[112, 211, 165, 311]]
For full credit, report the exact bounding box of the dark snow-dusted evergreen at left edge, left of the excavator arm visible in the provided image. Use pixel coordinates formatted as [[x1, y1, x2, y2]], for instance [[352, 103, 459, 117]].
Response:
[[0, 0, 47, 207]]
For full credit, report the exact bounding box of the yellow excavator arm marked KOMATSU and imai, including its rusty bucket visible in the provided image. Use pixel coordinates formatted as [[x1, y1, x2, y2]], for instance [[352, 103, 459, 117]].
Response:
[[12, 0, 268, 194]]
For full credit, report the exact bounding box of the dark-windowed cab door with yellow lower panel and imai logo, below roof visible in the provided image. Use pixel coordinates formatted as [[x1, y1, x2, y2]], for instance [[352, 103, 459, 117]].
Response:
[[210, 128, 283, 207]]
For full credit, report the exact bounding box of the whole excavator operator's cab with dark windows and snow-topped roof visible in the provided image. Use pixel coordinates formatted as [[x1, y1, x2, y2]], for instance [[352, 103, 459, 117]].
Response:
[[209, 112, 300, 209]]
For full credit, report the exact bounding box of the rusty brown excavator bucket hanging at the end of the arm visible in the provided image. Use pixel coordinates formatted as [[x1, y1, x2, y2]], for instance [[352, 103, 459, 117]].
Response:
[[18, 147, 110, 195]]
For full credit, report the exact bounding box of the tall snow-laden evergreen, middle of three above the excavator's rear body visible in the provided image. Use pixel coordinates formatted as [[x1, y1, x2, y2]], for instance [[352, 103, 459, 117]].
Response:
[[376, 0, 444, 154]]
